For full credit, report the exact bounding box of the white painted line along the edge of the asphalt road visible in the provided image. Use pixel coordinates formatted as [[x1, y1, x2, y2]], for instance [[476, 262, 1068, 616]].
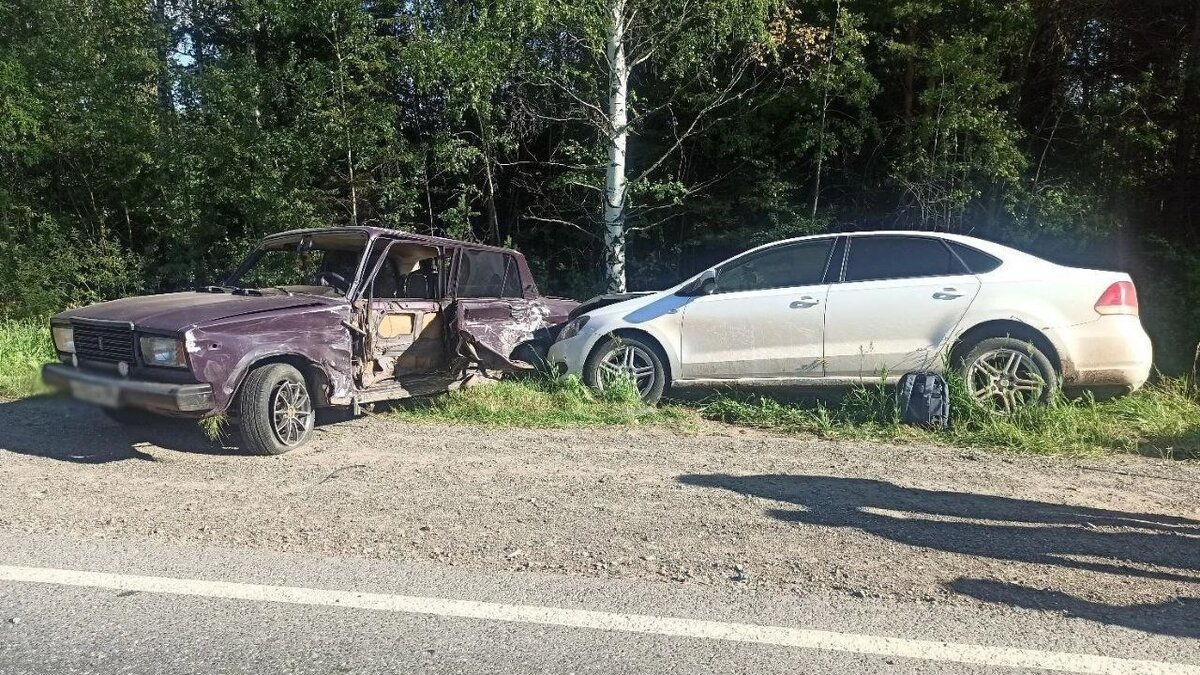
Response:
[[0, 566, 1200, 675]]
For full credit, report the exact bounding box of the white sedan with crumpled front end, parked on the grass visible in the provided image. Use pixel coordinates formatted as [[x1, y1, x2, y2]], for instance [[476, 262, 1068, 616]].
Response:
[[550, 232, 1152, 411]]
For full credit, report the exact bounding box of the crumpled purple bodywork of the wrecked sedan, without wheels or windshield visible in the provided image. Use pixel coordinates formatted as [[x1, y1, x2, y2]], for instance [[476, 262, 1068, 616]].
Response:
[[52, 227, 578, 414]]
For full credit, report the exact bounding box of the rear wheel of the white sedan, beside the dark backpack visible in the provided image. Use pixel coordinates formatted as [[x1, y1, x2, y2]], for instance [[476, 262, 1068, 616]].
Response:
[[959, 336, 1058, 414]]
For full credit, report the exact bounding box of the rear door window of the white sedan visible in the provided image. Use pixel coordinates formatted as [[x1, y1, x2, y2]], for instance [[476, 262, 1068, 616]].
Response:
[[846, 237, 967, 281]]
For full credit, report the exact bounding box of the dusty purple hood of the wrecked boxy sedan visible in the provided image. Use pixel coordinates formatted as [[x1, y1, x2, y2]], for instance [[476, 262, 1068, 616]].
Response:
[[55, 292, 335, 331]]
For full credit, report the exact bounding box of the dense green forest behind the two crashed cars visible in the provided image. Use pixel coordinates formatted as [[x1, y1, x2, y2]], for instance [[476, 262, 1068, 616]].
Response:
[[7, 0, 1200, 370]]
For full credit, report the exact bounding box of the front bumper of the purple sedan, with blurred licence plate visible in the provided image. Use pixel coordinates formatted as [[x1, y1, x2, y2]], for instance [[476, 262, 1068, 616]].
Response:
[[42, 363, 216, 414]]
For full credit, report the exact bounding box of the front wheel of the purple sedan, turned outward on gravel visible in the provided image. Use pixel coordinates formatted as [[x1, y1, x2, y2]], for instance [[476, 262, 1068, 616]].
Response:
[[238, 363, 317, 455]]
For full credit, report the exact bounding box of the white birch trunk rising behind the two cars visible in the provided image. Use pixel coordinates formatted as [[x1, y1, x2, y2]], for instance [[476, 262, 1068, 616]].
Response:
[[604, 0, 629, 293]]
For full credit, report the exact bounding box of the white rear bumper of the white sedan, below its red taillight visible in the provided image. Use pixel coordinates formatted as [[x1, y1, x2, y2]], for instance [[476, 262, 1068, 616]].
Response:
[[1046, 316, 1154, 389]]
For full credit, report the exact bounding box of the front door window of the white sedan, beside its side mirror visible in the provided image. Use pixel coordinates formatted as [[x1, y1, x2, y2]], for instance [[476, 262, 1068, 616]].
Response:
[[715, 238, 833, 293]]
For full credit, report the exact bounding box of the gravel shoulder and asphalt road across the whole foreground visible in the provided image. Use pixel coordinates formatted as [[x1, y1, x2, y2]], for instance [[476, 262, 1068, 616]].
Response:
[[0, 399, 1200, 675]]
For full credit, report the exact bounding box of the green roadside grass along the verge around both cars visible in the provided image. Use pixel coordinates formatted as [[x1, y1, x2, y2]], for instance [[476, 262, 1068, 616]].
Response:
[[0, 319, 1200, 459]]
